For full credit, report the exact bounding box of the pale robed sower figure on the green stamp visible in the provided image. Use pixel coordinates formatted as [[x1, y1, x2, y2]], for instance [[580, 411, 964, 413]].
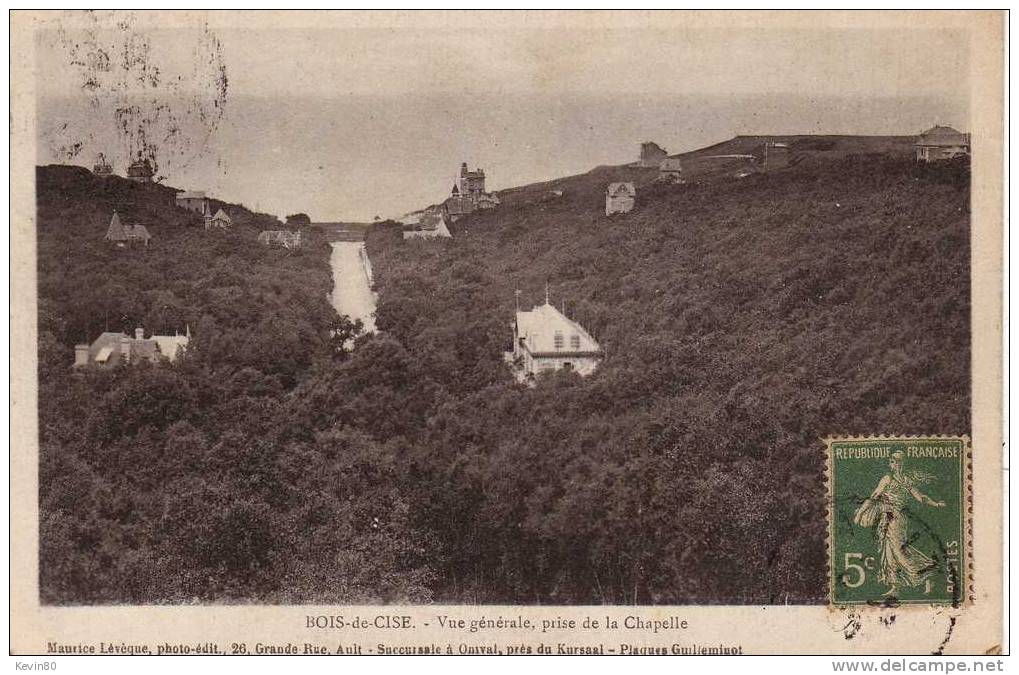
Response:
[[853, 452, 945, 595]]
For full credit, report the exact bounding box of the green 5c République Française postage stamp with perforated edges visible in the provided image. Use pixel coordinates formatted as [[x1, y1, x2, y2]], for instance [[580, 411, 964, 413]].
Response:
[[825, 436, 970, 606]]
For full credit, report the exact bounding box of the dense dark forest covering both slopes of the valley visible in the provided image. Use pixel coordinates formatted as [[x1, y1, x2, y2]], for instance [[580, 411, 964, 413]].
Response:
[[39, 141, 969, 604]]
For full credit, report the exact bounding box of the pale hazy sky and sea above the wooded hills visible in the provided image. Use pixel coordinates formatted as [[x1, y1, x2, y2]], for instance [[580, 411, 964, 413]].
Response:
[[36, 12, 969, 221]]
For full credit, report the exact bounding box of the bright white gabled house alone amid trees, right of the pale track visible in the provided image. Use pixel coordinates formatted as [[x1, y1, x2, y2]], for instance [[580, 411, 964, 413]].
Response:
[[506, 295, 602, 380]]
